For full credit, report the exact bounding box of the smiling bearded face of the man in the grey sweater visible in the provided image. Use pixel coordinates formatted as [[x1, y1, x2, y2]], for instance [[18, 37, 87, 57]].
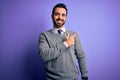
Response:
[[52, 8, 66, 28]]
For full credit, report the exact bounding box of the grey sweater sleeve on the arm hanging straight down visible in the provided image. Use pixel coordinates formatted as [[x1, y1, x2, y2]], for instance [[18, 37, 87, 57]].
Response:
[[75, 36, 88, 77]]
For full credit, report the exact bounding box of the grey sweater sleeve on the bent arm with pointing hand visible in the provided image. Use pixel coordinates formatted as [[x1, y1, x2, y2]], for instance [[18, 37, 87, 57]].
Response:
[[38, 33, 66, 62]]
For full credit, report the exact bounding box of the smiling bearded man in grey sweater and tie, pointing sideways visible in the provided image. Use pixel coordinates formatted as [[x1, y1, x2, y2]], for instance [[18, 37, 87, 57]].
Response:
[[39, 3, 88, 80]]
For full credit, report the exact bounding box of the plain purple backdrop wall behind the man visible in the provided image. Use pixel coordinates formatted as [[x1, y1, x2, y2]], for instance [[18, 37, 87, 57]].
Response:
[[0, 0, 120, 80]]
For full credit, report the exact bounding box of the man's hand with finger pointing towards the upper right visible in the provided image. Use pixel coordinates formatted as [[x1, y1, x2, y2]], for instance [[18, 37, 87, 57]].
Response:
[[65, 33, 78, 46]]
